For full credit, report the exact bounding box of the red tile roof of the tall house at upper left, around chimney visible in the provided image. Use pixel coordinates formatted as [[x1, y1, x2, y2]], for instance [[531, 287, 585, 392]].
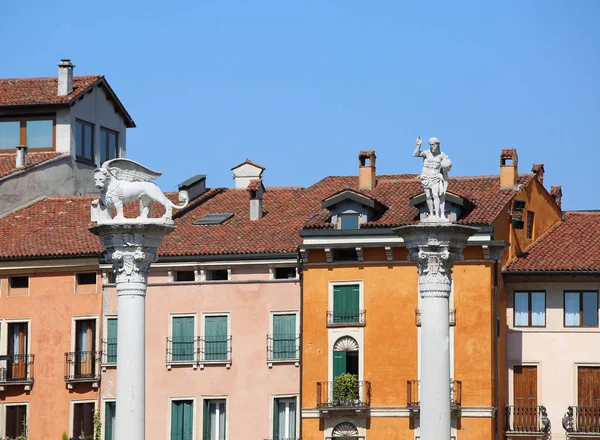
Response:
[[0, 75, 104, 106]]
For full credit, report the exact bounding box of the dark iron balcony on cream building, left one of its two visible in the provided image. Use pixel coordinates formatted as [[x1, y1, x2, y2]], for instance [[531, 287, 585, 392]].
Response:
[[504, 405, 550, 439]]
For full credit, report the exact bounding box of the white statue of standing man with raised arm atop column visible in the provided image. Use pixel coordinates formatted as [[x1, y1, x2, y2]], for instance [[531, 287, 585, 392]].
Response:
[[413, 136, 452, 221]]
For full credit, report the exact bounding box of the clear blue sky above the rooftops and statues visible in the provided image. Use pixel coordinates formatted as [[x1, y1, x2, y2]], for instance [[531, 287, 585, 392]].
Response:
[[0, 0, 600, 209]]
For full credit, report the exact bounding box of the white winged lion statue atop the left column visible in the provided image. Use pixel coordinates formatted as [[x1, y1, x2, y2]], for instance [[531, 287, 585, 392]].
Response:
[[92, 158, 189, 221]]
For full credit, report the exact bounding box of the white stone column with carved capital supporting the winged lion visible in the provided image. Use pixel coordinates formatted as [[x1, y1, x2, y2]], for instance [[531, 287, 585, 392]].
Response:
[[90, 219, 175, 440]]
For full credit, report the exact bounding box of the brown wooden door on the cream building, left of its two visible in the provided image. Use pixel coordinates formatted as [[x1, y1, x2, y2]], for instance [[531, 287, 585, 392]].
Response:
[[513, 365, 538, 432]]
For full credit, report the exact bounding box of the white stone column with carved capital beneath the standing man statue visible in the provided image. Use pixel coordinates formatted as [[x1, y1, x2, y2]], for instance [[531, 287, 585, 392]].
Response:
[[394, 221, 477, 440]]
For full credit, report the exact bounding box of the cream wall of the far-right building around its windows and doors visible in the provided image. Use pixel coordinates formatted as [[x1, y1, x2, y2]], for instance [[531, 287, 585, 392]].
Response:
[[507, 281, 600, 440]]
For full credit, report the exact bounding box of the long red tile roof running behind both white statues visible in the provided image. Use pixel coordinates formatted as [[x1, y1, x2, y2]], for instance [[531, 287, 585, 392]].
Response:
[[0, 175, 532, 259]]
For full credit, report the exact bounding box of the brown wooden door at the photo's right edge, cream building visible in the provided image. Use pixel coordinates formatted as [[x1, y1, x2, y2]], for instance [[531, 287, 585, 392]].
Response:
[[577, 367, 600, 432]]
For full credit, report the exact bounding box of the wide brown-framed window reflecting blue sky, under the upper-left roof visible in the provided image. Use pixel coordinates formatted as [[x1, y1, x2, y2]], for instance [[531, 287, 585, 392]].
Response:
[[0, 116, 54, 150]]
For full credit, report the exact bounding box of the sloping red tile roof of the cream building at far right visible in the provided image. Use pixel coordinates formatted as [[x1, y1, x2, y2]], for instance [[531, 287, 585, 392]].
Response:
[[504, 211, 600, 273]]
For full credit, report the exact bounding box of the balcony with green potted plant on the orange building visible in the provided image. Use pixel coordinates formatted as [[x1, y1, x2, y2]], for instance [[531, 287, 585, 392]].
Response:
[[317, 374, 371, 416]]
